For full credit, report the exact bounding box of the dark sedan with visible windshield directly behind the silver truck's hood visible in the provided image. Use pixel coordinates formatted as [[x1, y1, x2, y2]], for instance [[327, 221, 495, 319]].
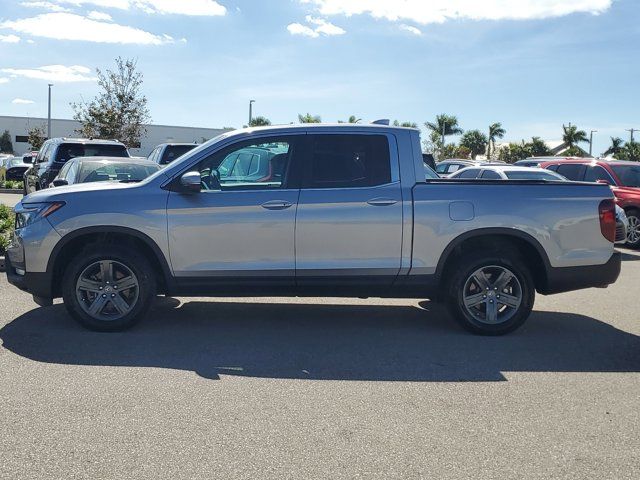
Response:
[[50, 157, 160, 187]]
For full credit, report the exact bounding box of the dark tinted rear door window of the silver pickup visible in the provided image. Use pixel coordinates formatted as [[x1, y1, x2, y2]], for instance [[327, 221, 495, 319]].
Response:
[[304, 134, 392, 188]]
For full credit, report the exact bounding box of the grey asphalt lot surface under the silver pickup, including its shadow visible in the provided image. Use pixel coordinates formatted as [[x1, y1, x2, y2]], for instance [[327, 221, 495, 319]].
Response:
[[0, 246, 640, 478]]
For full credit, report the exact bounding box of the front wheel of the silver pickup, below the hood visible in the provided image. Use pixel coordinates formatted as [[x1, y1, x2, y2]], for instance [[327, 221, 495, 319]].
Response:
[[62, 244, 156, 332]]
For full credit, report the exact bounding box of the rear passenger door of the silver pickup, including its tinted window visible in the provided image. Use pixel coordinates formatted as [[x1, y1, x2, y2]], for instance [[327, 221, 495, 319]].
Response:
[[295, 133, 402, 287]]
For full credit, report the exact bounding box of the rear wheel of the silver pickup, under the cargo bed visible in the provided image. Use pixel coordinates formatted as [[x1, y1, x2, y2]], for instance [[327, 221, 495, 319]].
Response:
[[446, 249, 535, 335]]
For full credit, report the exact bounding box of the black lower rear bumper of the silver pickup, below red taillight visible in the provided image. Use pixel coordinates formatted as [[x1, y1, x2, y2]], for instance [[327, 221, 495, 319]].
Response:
[[539, 252, 622, 295]]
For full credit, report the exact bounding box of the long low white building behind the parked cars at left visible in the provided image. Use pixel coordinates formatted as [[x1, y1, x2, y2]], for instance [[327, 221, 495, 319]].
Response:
[[0, 115, 226, 157]]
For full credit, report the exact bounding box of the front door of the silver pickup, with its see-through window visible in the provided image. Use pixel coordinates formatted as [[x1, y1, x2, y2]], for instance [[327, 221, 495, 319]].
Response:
[[167, 135, 302, 286]]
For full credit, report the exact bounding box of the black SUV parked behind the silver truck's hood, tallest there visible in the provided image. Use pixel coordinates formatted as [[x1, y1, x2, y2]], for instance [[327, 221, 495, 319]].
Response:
[[24, 138, 129, 195]]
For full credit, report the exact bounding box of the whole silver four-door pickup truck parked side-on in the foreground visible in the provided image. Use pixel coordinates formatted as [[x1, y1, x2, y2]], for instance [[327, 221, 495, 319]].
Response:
[[7, 125, 620, 335]]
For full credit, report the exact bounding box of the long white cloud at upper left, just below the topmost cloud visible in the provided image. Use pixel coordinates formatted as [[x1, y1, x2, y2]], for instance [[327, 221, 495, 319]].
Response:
[[0, 13, 174, 45]]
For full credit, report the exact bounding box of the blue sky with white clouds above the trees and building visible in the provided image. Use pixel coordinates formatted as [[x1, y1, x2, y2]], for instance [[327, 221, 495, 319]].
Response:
[[0, 0, 640, 153]]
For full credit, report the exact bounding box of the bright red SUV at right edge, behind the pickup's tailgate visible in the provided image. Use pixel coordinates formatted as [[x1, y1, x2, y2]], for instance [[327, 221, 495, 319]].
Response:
[[540, 158, 640, 248]]
